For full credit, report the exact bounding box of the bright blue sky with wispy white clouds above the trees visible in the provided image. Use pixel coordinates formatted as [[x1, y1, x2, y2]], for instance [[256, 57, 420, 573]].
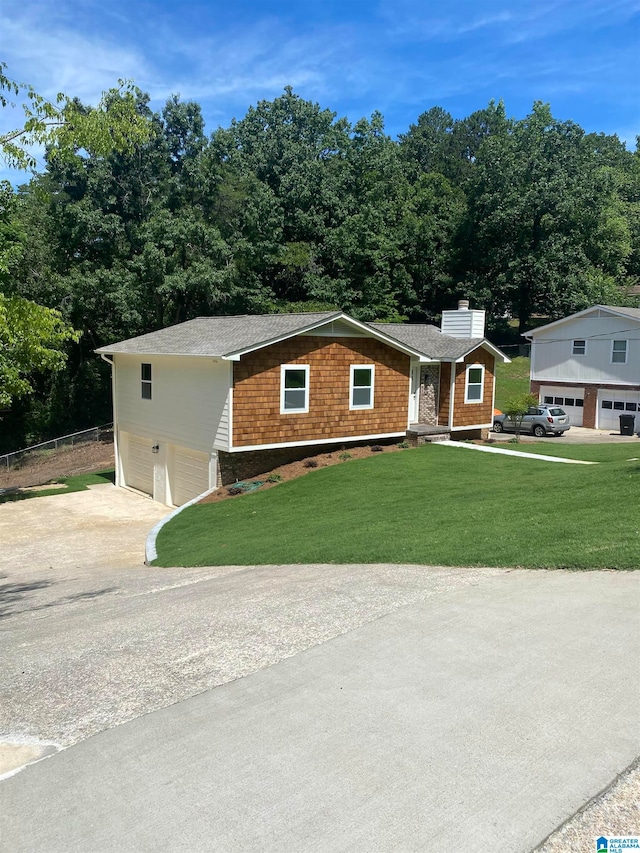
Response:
[[0, 0, 640, 180]]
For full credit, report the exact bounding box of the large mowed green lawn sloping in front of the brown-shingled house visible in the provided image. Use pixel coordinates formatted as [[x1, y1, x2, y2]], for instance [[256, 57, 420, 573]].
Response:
[[156, 442, 640, 569]]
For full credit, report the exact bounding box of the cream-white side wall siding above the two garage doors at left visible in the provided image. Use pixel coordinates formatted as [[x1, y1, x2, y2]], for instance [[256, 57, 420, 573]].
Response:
[[114, 355, 231, 455]]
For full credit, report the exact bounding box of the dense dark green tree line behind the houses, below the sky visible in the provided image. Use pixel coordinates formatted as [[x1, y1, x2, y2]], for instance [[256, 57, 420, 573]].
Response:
[[0, 89, 640, 452]]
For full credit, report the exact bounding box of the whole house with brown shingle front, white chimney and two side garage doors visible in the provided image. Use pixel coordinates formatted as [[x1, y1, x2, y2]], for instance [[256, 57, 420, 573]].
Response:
[[97, 303, 508, 506]]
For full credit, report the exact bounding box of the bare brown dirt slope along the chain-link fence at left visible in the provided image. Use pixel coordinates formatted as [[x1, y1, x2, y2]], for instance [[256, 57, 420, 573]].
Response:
[[0, 441, 114, 489]]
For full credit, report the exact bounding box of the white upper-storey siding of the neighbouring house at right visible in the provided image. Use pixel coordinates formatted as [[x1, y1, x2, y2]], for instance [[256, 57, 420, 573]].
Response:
[[531, 310, 640, 385]]
